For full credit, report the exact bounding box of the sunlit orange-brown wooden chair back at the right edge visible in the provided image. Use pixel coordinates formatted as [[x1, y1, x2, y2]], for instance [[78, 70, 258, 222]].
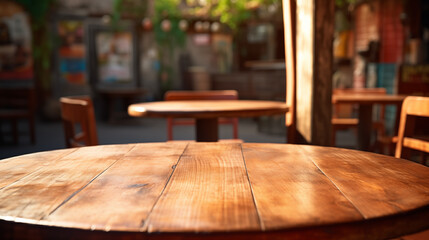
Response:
[[395, 96, 429, 158]]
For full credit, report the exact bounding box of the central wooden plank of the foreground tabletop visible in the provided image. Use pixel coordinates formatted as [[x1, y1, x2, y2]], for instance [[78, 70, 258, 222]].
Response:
[[145, 143, 260, 232]]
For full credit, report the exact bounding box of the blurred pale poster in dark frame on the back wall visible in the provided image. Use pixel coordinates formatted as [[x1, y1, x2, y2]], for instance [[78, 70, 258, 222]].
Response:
[[87, 21, 139, 89]]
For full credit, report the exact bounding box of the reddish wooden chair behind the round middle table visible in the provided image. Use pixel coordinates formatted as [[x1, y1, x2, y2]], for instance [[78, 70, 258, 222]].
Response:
[[164, 90, 238, 141]]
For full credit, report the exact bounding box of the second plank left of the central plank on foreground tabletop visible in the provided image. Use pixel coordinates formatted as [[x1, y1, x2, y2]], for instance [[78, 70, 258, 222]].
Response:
[[0, 145, 133, 220]]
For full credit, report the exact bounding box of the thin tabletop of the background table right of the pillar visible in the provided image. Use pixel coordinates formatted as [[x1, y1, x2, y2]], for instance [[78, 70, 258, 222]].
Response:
[[332, 94, 407, 104]]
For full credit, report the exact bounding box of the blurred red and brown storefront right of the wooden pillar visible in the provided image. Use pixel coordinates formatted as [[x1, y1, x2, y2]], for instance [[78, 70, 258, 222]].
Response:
[[333, 0, 429, 131]]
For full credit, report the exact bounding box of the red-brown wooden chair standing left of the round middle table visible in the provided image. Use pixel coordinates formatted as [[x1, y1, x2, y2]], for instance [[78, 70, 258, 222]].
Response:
[[60, 96, 98, 148]]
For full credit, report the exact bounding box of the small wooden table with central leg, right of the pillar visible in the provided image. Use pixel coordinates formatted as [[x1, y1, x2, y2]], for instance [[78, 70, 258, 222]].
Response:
[[332, 94, 407, 150]]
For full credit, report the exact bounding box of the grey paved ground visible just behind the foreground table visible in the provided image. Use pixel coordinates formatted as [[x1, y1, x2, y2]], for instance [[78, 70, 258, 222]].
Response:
[[0, 118, 355, 159]]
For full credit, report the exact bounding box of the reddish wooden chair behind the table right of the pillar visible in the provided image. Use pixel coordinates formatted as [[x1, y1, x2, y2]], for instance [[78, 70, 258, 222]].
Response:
[[331, 88, 386, 146]]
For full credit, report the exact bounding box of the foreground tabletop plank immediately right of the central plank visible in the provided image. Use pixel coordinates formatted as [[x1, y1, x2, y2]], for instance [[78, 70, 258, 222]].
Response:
[[243, 143, 363, 230]]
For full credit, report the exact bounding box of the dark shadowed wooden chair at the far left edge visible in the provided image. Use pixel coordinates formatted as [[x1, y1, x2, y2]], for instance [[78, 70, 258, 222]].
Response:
[[0, 88, 36, 144]]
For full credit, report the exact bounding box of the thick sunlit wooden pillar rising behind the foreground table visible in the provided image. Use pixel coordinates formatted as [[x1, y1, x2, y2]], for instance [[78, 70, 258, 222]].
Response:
[[283, 0, 335, 145]]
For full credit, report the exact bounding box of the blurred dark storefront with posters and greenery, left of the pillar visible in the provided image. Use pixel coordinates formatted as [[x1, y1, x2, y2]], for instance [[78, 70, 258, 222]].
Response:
[[0, 0, 285, 118]]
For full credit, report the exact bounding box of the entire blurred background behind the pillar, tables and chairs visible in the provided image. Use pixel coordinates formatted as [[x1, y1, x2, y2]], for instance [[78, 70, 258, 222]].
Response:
[[0, 0, 429, 156]]
